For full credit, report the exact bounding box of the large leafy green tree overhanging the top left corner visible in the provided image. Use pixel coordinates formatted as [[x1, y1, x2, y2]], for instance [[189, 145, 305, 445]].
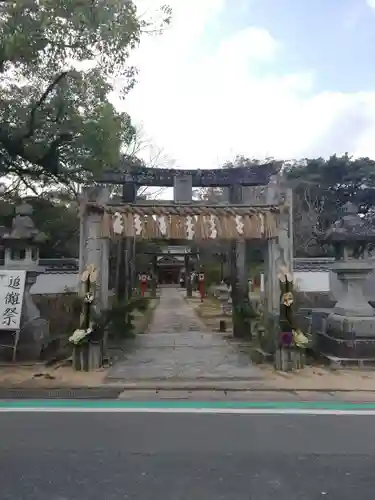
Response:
[[0, 0, 171, 188]]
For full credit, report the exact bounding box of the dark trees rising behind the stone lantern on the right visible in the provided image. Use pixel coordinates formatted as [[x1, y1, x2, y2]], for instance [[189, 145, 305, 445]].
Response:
[[285, 154, 375, 256]]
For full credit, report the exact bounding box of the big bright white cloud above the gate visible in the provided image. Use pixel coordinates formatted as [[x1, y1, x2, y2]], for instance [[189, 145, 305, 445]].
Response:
[[112, 0, 375, 168]]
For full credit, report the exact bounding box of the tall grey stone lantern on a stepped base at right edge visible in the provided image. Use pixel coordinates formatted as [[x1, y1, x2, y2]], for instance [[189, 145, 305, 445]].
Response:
[[318, 203, 375, 358]]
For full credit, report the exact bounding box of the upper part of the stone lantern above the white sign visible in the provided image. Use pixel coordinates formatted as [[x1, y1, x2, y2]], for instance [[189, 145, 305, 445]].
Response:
[[3, 203, 47, 271]]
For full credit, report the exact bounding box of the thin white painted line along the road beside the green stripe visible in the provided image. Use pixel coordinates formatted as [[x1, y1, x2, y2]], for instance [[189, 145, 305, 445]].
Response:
[[0, 406, 375, 416]]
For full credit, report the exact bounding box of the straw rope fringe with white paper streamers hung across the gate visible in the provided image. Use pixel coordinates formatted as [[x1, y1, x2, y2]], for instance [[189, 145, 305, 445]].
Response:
[[98, 205, 279, 240]]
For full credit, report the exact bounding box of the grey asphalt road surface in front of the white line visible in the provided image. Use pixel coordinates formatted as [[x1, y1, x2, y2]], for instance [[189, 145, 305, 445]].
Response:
[[0, 413, 375, 500]]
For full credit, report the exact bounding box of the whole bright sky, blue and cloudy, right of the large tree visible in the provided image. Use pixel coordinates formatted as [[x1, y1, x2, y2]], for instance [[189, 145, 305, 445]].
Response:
[[116, 0, 375, 169]]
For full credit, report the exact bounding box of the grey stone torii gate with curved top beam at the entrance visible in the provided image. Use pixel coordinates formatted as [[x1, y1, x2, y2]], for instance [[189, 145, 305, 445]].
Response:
[[80, 162, 293, 337]]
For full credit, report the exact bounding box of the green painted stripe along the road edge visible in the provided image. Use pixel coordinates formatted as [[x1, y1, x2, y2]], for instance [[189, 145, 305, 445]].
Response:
[[0, 399, 375, 411]]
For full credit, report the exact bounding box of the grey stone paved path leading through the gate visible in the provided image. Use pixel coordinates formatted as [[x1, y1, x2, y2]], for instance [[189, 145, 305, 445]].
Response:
[[107, 288, 261, 382]]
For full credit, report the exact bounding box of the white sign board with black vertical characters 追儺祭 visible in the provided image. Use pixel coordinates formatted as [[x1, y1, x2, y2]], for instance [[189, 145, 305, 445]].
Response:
[[0, 269, 26, 331]]
